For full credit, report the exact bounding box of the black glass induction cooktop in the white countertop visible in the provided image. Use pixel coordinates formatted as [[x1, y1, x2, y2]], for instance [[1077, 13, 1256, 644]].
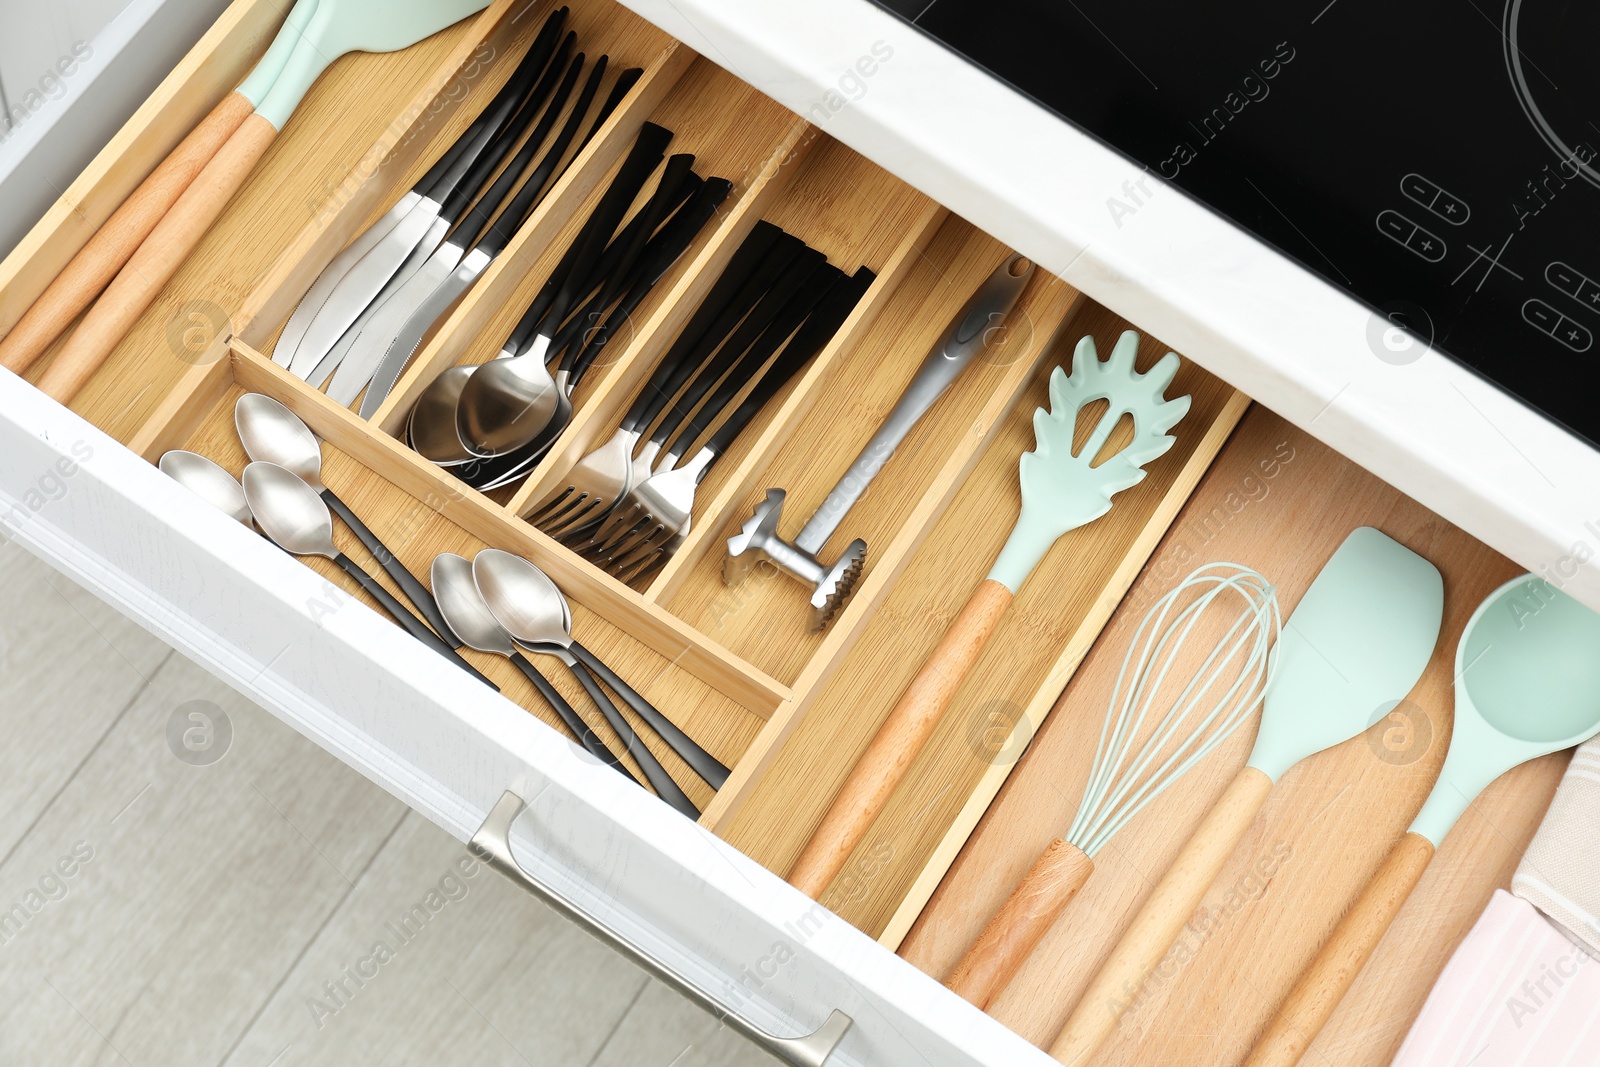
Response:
[[875, 0, 1600, 443]]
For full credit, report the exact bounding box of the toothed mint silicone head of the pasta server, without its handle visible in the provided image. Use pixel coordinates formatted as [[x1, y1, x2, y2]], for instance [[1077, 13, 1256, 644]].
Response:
[[989, 330, 1189, 592]]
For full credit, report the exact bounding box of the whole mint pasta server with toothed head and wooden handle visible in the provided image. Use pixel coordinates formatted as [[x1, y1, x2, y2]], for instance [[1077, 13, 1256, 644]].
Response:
[[789, 330, 1189, 899]]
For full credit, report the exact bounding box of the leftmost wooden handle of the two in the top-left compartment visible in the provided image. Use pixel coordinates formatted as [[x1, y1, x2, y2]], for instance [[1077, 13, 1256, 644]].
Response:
[[0, 93, 256, 374]]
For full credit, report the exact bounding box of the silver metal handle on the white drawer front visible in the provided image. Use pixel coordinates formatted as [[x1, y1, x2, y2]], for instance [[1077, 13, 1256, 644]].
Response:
[[470, 789, 851, 1067]]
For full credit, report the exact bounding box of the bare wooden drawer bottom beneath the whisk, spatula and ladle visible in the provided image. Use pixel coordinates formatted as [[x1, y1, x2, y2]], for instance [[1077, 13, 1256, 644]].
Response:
[[901, 408, 1565, 1067]]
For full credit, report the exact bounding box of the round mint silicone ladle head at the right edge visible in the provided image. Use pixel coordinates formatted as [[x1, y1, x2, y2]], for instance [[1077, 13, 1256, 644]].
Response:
[[1411, 574, 1600, 845]]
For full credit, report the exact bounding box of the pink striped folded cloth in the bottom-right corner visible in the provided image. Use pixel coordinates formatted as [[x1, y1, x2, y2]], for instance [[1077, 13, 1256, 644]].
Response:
[[1394, 895, 1600, 1067]]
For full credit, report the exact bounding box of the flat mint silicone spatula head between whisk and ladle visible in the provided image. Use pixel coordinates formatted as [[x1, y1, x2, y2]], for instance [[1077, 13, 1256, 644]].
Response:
[[1250, 526, 1445, 781]]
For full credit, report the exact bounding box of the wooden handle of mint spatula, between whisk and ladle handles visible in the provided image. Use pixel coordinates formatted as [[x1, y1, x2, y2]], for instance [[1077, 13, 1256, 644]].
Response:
[[1050, 766, 1272, 1064]]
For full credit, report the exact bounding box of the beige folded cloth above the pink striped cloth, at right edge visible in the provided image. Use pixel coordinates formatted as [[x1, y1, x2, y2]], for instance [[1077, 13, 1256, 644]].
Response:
[[1510, 737, 1600, 953]]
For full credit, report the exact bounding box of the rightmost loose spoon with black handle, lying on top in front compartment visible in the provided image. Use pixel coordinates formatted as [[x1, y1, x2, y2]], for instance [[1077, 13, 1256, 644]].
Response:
[[472, 549, 728, 789]]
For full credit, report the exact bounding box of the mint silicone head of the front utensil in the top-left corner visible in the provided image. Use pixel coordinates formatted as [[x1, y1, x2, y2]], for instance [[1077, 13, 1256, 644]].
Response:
[[256, 0, 488, 130]]
